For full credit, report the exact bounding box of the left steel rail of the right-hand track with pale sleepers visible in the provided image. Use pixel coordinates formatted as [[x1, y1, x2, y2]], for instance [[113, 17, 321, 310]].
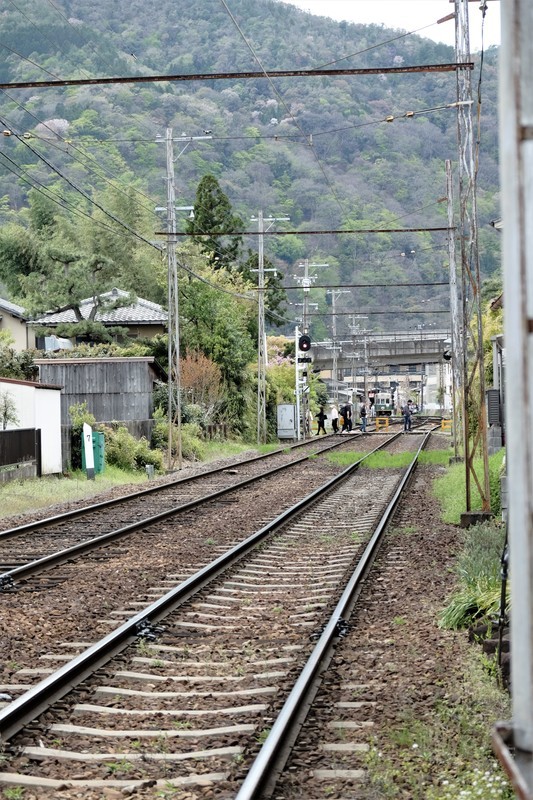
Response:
[[0, 434, 400, 742]]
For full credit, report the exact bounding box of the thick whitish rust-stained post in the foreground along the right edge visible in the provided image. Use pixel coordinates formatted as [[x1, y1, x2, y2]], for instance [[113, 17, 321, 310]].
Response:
[[494, 0, 533, 800]]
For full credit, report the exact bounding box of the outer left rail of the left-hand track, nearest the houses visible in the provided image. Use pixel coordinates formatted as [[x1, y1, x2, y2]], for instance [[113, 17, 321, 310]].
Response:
[[0, 434, 340, 541]]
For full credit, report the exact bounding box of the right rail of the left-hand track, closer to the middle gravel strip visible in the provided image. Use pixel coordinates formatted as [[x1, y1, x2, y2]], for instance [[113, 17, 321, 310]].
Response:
[[0, 434, 376, 592]]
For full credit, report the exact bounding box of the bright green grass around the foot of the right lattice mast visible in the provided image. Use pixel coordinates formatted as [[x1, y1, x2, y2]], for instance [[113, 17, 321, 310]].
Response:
[[433, 449, 505, 524]]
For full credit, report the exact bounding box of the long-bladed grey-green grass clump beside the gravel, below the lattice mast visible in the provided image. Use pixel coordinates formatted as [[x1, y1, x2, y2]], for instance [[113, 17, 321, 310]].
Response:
[[439, 520, 509, 629]]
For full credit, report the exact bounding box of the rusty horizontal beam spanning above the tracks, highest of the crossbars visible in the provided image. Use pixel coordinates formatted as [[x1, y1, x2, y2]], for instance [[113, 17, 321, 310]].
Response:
[[0, 62, 474, 89]]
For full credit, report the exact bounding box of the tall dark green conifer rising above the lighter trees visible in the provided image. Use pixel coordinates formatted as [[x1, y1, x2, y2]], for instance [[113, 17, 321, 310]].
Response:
[[187, 175, 243, 269]]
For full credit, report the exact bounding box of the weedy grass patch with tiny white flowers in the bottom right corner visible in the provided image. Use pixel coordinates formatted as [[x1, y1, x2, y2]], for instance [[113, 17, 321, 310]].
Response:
[[367, 651, 514, 800]]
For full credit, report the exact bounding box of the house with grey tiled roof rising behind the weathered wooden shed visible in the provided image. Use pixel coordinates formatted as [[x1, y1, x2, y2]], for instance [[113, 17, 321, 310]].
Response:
[[28, 289, 168, 350]]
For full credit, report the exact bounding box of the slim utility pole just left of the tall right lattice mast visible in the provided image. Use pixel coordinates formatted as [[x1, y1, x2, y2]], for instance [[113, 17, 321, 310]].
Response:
[[446, 160, 464, 461]]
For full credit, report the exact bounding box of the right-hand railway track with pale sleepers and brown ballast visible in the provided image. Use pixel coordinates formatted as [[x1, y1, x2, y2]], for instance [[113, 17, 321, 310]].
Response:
[[0, 424, 436, 798]]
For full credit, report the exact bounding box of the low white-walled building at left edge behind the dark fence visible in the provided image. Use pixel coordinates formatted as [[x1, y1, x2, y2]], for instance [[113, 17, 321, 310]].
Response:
[[0, 378, 63, 477]]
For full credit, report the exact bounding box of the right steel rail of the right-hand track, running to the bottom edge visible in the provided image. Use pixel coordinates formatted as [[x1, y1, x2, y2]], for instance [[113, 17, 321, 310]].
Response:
[[235, 431, 432, 800]]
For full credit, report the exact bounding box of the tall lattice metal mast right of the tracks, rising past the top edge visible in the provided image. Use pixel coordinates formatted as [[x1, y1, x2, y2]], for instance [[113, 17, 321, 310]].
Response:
[[455, 0, 490, 518]]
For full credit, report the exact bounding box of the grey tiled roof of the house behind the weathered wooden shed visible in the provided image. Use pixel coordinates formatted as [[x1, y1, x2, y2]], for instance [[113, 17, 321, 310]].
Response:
[[32, 289, 167, 325]]
